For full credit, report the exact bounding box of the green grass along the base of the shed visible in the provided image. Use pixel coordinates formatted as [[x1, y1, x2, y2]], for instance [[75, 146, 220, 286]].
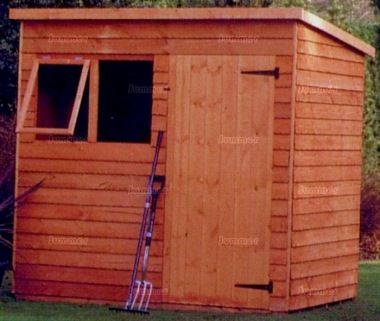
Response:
[[0, 261, 380, 321]]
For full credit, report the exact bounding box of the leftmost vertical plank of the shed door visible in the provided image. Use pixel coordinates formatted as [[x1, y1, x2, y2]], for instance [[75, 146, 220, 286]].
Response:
[[164, 56, 191, 302]]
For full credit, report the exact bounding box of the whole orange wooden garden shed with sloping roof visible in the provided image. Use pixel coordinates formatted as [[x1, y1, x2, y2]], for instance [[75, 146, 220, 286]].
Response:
[[10, 8, 374, 311]]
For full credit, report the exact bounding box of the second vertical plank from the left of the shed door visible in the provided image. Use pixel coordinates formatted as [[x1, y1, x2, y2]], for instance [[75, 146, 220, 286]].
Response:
[[183, 55, 208, 300]]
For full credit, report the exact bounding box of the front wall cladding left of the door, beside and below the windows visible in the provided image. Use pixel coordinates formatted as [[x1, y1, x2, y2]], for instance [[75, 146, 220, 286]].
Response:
[[15, 56, 167, 303]]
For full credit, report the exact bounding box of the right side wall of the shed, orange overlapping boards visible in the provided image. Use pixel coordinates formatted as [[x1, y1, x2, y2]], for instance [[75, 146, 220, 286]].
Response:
[[289, 24, 364, 310]]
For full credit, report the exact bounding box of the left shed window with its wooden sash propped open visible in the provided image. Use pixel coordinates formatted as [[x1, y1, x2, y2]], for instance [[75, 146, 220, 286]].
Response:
[[17, 59, 90, 139]]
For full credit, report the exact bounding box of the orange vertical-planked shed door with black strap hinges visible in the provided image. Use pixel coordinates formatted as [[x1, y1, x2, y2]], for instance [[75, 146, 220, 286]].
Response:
[[163, 56, 275, 309]]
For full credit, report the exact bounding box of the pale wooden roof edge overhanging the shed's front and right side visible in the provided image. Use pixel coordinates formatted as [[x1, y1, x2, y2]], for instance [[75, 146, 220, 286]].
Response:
[[10, 8, 375, 57]]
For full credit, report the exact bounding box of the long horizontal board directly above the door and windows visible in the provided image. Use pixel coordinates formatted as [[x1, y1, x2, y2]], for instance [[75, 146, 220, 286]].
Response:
[[23, 38, 293, 55]]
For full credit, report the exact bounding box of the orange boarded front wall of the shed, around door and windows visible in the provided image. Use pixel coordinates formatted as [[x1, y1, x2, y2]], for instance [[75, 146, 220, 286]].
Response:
[[15, 21, 294, 310]]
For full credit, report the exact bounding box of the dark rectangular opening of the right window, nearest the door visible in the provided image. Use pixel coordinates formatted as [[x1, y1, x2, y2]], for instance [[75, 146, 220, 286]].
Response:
[[98, 61, 153, 143]]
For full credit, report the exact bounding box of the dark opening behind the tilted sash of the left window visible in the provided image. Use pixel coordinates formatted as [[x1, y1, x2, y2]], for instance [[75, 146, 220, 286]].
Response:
[[36, 65, 89, 141]]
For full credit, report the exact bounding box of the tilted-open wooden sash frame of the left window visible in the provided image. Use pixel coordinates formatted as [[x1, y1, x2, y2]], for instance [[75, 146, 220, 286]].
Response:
[[16, 59, 90, 135]]
